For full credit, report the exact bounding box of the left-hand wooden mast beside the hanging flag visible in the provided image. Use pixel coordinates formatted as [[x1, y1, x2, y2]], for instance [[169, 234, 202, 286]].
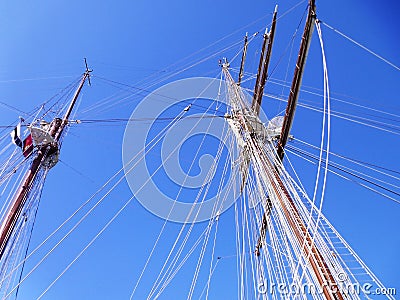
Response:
[[0, 59, 91, 259]]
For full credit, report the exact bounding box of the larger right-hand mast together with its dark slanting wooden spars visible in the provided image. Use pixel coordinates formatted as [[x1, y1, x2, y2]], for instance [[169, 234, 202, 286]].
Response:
[[228, 0, 344, 300]]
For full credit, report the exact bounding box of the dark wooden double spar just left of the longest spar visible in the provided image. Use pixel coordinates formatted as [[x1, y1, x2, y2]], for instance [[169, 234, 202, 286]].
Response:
[[251, 6, 278, 116]]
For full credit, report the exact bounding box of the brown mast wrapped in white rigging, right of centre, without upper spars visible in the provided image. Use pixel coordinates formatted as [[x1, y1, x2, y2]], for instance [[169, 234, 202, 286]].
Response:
[[223, 65, 344, 300]]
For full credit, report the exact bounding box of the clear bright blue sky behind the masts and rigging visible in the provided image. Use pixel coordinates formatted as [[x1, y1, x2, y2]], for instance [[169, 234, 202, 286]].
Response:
[[0, 0, 400, 299]]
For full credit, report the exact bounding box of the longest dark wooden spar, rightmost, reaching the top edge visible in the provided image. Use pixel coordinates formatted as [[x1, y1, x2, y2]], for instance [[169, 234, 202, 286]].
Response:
[[277, 0, 316, 160]]
